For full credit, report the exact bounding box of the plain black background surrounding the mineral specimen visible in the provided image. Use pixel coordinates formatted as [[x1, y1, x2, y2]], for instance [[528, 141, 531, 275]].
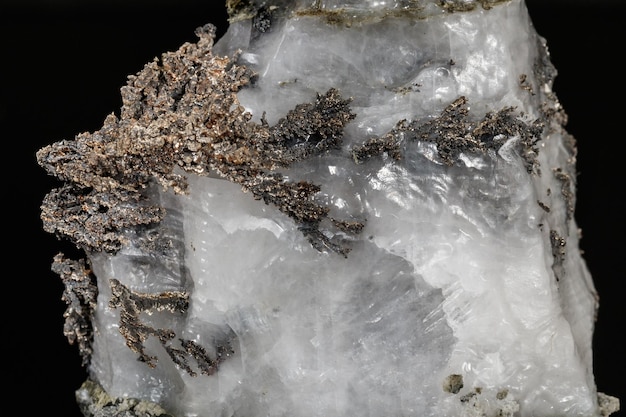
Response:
[[0, 0, 626, 417]]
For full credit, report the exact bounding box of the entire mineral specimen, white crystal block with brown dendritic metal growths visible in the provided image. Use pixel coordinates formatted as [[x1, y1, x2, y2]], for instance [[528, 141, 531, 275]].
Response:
[[37, 0, 619, 417]]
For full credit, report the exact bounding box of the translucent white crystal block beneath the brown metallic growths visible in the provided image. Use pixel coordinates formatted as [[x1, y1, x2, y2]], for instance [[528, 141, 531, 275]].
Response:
[[42, 0, 616, 417]]
